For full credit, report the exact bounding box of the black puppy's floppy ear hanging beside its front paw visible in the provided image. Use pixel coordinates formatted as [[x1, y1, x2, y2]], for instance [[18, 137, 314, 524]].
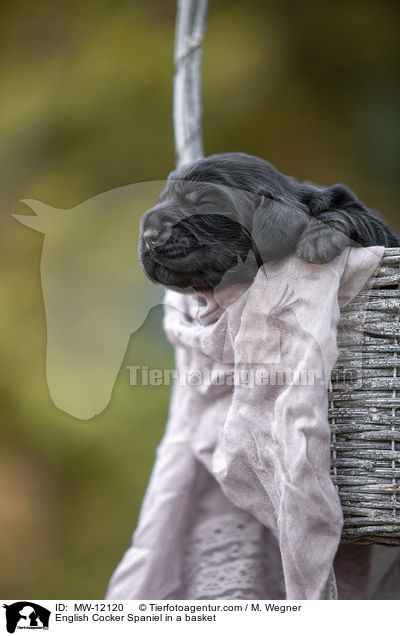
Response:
[[251, 196, 310, 263]]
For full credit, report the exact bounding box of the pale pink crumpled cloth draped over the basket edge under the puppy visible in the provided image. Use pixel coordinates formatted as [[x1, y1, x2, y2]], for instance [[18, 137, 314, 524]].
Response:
[[107, 247, 384, 599]]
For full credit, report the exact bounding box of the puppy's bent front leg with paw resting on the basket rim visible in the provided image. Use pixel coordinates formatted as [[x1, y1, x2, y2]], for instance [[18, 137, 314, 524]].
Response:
[[296, 183, 362, 263]]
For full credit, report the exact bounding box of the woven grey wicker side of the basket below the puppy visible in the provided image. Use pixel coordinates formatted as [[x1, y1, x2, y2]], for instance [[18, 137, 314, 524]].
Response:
[[329, 248, 400, 545]]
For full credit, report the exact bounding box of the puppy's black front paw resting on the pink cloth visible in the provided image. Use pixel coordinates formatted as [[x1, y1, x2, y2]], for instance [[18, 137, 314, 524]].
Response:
[[296, 221, 352, 263]]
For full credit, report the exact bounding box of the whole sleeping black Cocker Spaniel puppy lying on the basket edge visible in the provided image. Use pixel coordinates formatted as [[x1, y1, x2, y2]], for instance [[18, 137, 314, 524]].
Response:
[[139, 152, 400, 291]]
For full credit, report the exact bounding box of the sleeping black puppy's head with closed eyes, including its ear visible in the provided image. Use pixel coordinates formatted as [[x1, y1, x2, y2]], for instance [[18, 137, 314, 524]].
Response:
[[139, 153, 308, 291]]
